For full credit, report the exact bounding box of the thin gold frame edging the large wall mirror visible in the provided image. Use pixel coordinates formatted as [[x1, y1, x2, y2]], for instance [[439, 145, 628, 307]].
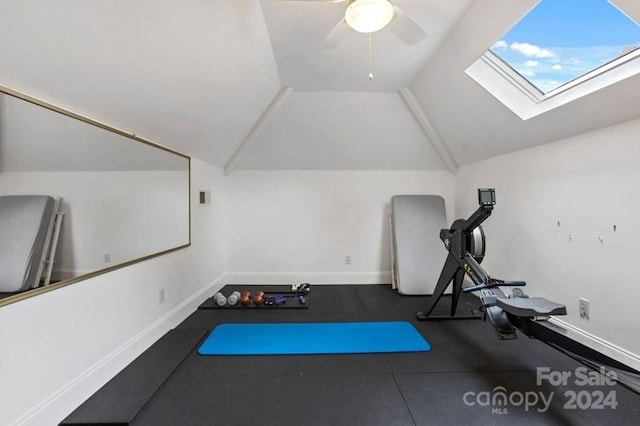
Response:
[[0, 85, 191, 307]]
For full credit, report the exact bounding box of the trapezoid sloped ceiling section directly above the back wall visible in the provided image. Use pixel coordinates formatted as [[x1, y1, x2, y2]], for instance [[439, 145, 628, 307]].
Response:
[[238, 91, 446, 170]]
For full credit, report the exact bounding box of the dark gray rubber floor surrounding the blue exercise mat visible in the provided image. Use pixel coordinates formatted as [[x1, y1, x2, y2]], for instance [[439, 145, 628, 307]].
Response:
[[62, 285, 640, 426]]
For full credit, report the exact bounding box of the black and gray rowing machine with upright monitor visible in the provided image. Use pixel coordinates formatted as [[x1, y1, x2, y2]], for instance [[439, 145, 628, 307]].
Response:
[[417, 188, 640, 393]]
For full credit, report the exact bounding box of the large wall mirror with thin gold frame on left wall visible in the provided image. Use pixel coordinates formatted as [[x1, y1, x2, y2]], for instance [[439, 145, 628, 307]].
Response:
[[0, 86, 190, 306]]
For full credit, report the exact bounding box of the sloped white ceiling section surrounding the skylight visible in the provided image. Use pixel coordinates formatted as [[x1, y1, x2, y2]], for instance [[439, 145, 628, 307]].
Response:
[[411, 0, 640, 165]]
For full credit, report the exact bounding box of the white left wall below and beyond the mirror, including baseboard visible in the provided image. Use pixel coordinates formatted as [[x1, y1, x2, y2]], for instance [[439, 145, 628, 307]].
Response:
[[0, 159, 225, 425]]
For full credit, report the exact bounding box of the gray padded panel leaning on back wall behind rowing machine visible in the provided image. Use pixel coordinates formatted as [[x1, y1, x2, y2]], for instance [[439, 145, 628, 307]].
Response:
[[391, 195, 448, 294]]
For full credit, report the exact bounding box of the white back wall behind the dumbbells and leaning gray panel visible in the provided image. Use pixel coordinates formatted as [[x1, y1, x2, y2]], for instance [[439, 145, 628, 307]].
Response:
[[227, 171, 454, 284]]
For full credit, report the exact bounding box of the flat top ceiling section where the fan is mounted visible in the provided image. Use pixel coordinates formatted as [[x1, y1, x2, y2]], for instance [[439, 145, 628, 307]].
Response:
[[261, 0, 472, 92]]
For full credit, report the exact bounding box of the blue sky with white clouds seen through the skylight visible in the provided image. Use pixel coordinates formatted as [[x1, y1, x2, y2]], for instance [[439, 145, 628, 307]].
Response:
[[490, 0, 640, 93]]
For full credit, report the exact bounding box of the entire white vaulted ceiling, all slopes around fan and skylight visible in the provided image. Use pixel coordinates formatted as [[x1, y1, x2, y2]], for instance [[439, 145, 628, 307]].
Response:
[[0, 0, 640, 171]]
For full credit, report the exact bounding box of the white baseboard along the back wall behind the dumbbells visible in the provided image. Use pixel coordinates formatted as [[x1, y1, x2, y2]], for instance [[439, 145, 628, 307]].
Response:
[[225, 271, 391, 285]]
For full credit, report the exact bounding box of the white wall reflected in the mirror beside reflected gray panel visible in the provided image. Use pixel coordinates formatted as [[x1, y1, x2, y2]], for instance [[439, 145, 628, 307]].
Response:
[[0, 171, 189, 280]]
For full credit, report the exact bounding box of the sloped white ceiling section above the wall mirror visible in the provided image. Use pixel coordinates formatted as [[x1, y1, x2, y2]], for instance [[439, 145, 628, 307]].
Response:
[[0, 0, 280, 166]]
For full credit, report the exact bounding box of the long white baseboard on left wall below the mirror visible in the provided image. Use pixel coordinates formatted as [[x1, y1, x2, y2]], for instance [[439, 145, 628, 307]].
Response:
[[13, 274, 225, 425]]
